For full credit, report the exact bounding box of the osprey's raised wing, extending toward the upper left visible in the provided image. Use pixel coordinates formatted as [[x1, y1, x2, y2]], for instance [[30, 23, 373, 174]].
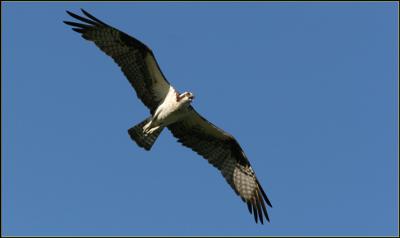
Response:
[[64, 9, 170, 113]]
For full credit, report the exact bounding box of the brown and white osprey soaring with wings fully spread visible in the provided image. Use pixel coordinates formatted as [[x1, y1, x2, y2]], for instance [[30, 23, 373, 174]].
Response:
[[64, 9, 272, 223]]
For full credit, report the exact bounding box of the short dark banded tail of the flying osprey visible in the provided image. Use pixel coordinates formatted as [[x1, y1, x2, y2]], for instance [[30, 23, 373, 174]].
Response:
[[128, 117, 164, 150]]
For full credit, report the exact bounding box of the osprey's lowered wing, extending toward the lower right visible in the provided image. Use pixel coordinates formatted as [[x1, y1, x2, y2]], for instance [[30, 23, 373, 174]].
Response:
[[168, 107, 272, 223]]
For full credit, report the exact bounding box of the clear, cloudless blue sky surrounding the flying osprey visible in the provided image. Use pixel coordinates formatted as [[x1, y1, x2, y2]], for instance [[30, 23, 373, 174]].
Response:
[[1, 2, 399, 235]]
